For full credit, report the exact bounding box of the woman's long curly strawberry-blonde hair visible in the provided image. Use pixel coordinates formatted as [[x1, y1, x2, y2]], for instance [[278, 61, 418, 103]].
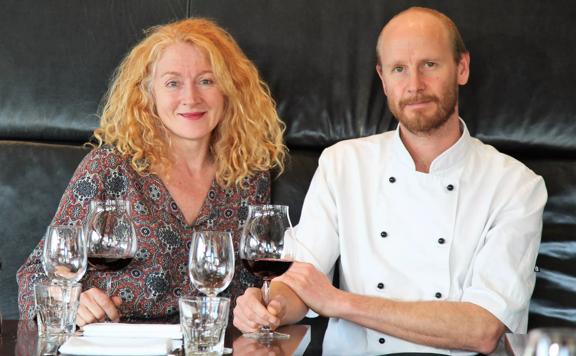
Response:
[[94, 18, 287, 187]]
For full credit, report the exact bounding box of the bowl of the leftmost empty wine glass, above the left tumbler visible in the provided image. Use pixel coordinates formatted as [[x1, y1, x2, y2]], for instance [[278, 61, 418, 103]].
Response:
[[42, 225, 87, 284]]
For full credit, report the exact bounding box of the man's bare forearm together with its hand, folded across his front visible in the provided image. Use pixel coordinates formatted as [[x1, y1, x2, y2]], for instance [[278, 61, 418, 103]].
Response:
[[282, 263, 506, 353]]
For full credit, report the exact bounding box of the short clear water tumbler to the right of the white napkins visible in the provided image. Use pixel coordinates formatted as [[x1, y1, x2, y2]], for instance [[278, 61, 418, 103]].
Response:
[[179, 297, 230, 356]]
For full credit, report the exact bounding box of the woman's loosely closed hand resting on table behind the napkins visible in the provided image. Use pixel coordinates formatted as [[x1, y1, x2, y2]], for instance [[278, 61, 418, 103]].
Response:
[[76, 288, 122, 326]]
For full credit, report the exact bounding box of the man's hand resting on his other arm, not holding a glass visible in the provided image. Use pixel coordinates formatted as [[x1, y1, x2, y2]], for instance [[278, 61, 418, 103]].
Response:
[[278, 262, 344, 316]]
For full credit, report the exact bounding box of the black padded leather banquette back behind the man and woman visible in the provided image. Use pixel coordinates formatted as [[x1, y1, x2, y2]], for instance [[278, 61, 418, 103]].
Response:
[[0, 0, 576, 327]]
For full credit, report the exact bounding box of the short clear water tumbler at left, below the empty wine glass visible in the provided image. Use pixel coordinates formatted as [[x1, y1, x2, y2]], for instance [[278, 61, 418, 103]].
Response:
[[34, 282, 82, 337]]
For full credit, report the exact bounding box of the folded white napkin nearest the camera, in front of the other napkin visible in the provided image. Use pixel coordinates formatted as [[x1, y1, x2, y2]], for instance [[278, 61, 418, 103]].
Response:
[[58, 336, 172, 356]]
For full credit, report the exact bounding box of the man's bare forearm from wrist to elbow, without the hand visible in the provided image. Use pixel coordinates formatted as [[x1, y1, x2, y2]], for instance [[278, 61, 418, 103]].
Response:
[[329, 292, 506, 353]]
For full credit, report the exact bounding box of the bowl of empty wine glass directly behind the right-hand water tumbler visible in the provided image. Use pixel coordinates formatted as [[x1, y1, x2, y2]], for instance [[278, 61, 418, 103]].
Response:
[[188, 231, 234, 297]]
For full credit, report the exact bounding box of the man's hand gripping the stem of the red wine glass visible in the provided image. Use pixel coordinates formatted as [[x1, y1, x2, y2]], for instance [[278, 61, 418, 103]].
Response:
[[234, 288, 286, 332]]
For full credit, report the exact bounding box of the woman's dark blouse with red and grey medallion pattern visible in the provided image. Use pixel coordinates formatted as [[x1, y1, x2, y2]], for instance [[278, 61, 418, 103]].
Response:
[[17, 146, 270, 322]]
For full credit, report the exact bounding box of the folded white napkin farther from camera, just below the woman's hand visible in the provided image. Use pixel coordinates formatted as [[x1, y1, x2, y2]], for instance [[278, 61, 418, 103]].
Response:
[[82, 323, 182, 339]]
